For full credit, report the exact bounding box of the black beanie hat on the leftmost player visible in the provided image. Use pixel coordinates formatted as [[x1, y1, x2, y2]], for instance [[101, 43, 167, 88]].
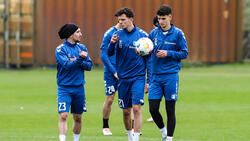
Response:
[[58, 24, 78, 39]]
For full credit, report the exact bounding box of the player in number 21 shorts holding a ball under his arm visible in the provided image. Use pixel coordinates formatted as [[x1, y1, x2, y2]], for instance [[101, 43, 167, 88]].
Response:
[[108, 8, 150, 141]]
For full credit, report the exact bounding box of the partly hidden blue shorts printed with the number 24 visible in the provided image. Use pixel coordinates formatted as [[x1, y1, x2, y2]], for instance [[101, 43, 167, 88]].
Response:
[[104, 72, 118, 95]]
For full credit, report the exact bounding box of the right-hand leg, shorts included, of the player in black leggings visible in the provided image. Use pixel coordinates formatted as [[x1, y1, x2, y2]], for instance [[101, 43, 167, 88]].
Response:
[[164, 74, 179, 141]]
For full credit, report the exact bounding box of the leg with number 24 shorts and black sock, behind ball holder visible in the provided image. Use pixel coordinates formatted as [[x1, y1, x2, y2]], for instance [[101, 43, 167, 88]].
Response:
[[102, 80, 117, 135]]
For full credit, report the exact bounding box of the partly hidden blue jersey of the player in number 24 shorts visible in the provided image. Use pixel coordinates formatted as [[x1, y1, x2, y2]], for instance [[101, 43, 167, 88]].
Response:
[[100, 26, 117, 75]]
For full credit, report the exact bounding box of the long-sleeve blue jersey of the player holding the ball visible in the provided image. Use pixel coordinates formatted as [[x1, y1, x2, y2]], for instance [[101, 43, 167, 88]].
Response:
[[108, 26, 151, 83]]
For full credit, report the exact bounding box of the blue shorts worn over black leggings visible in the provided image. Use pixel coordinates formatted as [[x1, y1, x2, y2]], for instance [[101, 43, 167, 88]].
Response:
[[148, 73, 179, 101]]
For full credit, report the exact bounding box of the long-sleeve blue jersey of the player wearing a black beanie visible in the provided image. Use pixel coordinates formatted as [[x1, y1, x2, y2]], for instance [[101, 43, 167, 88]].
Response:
[[55, 41, 93, 86]]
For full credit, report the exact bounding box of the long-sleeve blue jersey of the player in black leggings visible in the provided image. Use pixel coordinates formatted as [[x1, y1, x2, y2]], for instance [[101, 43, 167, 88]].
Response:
[[149, 24, 188, 74]]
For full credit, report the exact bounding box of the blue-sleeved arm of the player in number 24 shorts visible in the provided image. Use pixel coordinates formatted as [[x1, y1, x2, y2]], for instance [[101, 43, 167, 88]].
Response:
[[101, 37, 116, 74]]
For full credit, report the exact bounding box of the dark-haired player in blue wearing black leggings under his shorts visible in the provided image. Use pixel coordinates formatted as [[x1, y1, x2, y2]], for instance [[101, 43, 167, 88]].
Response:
[[148, 5, 188, 141]]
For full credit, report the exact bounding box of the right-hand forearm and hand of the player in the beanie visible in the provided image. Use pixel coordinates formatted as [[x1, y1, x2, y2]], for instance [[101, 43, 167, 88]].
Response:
[[79, 49, 93, 71]]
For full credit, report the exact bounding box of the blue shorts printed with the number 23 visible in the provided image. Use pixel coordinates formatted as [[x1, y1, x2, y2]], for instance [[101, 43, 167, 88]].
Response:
[[57, 85, 86, 114]]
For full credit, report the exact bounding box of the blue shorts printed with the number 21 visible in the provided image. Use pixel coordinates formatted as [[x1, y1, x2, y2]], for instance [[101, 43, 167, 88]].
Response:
[[118, 76, 145, 109]]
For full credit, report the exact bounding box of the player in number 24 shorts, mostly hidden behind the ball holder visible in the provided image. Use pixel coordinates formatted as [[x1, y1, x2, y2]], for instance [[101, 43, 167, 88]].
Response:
[[100, 23, 120, 135]]
